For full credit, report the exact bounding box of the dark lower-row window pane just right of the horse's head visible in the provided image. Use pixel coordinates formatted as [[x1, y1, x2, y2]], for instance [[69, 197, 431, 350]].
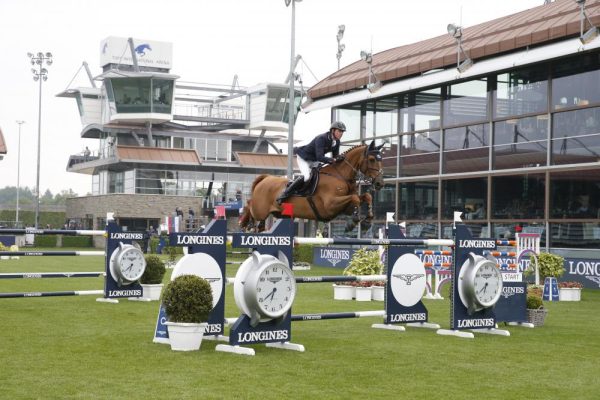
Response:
[[397, 181, 438, 220]]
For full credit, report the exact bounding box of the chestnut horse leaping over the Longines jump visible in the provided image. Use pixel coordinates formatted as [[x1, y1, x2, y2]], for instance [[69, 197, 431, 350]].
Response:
[[239, 141, 385, 231]]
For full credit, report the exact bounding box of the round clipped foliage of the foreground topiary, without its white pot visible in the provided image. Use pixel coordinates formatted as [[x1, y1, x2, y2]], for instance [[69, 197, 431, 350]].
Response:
[[162, 275, 212, 324]]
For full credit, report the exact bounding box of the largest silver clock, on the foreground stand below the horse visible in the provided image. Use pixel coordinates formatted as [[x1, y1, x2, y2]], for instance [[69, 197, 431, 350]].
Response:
[[233, 251, 296, 326]]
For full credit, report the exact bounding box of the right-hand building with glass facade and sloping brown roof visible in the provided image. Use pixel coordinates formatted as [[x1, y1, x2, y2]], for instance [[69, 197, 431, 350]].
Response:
[[305, 0, 600, 256]]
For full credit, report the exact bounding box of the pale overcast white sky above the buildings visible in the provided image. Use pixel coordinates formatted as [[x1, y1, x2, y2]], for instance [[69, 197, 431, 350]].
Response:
[[0, 0, 548, 195]]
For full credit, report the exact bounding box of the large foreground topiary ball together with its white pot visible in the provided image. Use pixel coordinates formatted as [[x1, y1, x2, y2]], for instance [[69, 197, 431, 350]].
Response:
[[162, 275, 213, 351]]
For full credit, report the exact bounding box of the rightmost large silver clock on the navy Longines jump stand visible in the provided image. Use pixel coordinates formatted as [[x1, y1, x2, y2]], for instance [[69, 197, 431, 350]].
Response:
[[458, 253, 503, 315]]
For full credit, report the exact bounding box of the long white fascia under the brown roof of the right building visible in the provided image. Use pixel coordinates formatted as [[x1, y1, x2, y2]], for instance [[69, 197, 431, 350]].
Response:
[[302, 38, 600, 113]]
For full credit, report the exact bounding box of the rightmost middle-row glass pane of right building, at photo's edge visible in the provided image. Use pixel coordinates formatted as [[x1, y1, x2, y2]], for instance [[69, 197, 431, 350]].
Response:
[[552, 108, 600, 165]]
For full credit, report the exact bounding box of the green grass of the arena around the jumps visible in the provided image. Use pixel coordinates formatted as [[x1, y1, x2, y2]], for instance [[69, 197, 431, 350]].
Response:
[[0, 257, 600, 400]]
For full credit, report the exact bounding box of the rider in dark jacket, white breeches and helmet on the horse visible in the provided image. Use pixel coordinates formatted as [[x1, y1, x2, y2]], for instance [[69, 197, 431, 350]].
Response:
[[277, 121, 346, 205]]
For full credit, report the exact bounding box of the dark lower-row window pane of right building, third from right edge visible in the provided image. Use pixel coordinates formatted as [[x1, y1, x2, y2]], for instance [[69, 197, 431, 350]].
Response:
[[442, 178, 487, 220]]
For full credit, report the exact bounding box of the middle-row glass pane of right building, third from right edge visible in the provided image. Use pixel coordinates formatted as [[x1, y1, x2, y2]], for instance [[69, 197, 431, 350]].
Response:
[[444, 124, 490, 173]]
